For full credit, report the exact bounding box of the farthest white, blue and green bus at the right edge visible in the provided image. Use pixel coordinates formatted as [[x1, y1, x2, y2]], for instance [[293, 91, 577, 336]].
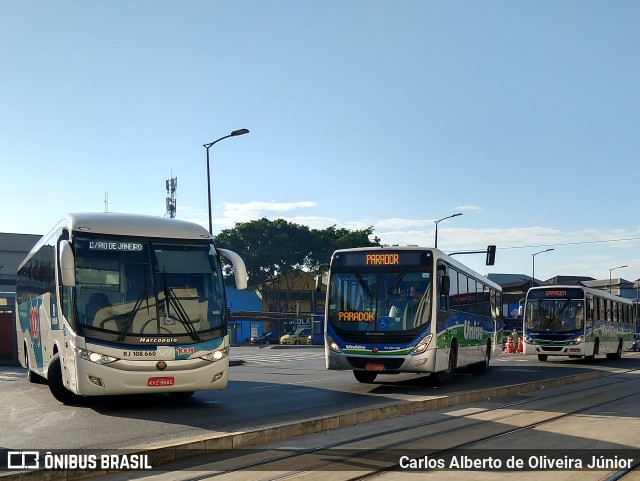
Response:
[[523, 286, 635, 361]]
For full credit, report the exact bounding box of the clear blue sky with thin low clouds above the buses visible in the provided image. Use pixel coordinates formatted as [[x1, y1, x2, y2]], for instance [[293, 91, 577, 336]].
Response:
[[0, 0, 640, 280]]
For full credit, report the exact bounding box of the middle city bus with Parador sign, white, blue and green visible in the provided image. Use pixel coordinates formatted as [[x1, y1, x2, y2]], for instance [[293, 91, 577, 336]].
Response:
[[325, 247, 502, 383]]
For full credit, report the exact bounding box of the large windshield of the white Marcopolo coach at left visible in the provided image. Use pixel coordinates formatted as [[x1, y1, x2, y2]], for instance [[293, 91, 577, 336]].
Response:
[[74, 238, 226, 342]]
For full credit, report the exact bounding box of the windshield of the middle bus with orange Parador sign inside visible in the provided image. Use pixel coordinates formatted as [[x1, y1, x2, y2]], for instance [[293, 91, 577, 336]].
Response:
[[328, 269, 432, 335]]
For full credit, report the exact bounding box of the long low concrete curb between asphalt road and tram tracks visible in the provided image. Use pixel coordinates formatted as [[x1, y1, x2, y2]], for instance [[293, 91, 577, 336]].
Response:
[[0, 373, 600, 481]]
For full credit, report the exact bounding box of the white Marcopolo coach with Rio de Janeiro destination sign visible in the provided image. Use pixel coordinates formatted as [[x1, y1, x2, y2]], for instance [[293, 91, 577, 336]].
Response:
[[16, 213, 246, 403]]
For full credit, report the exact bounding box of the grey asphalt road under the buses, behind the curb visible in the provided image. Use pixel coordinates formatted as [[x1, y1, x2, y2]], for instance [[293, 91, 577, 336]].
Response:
[[0, 346, 640, 449]]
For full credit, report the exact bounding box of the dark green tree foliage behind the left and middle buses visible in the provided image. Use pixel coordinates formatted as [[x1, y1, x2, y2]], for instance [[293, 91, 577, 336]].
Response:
[[215, 218, 379, 285]]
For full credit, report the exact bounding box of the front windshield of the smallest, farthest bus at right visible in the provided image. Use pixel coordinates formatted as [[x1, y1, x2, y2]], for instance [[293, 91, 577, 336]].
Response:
[[525, 299, 584, 333]]
